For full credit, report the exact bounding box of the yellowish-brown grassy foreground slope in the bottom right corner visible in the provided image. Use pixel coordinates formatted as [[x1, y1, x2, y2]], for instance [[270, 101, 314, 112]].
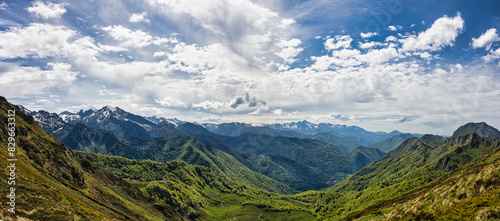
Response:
[[346, 140, 500, 220]]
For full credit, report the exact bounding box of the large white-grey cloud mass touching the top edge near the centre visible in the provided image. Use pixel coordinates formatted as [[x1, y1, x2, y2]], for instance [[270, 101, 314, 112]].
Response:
[[146, 0, 302, 70]]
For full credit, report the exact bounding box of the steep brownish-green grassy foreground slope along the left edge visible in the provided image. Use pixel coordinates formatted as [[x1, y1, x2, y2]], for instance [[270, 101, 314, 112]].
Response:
[[0, 97, 180, 220]]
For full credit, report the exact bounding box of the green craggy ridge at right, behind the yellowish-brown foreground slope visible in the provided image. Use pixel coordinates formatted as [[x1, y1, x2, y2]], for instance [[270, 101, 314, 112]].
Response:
[[310, 134, 496, 219]]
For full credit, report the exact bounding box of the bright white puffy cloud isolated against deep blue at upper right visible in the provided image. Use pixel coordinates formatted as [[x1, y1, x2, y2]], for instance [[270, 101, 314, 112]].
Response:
[[402, 13, 464, 51]]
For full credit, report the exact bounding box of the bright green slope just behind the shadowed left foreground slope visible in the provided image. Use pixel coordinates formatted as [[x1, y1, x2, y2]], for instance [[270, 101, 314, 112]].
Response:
[[81, 152, 314, 220]]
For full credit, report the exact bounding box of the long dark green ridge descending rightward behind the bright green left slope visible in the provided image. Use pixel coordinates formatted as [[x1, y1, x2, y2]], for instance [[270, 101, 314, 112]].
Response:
[[56, 124, 296, 194]]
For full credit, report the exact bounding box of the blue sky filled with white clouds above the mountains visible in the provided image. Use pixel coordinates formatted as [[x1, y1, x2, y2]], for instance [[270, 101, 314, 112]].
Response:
[[0, 0, 500, 135]]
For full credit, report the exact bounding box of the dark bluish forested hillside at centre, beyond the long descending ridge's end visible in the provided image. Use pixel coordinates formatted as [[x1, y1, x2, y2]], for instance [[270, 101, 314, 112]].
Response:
[[225, 133, 360, 191]]
